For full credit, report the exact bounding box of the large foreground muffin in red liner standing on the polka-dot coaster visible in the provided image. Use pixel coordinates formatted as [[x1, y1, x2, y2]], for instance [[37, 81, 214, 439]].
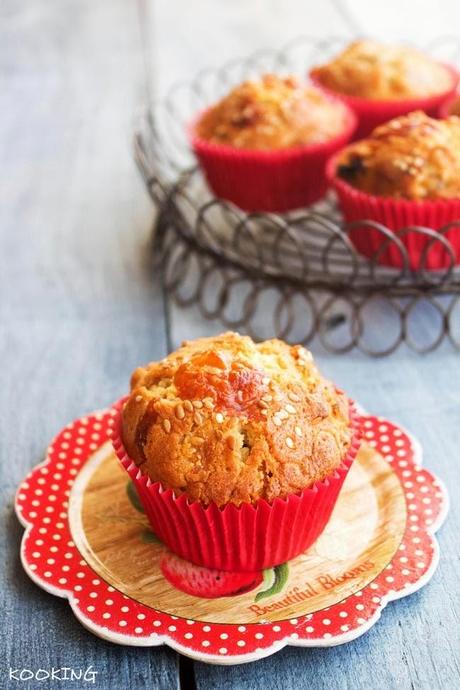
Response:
[[114, 333, 358, 571]]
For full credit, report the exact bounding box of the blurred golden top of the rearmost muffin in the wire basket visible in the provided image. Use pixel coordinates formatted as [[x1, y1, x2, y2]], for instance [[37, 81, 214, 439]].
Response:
[[311, 40, 453, 100]]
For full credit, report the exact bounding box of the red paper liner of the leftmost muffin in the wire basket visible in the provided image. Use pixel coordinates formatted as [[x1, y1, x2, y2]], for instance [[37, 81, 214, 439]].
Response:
[[189, 99, 356, 213]]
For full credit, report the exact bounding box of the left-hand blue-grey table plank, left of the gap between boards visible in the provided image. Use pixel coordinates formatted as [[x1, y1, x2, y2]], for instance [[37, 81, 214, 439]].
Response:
[[0, 0, 178, 690]]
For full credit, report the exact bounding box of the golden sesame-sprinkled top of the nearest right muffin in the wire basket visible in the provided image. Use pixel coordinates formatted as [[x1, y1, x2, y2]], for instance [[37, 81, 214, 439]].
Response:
[[336, 111, 460, 200]]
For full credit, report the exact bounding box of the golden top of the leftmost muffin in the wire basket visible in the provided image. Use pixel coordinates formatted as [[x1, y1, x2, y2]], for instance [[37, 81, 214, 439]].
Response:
[[196, 74, 347, 151]]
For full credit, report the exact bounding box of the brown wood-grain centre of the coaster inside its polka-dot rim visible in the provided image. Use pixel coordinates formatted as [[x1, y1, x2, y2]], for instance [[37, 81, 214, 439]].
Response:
[[69, 443, 406, 624]]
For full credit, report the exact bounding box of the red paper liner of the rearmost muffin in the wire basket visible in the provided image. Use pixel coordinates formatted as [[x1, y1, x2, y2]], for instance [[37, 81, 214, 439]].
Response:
[[310, 65, 459, 140]]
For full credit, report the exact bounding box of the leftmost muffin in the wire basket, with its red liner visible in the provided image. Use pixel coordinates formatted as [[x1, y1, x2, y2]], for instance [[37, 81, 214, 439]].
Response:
[[189, 74, 355, 212]]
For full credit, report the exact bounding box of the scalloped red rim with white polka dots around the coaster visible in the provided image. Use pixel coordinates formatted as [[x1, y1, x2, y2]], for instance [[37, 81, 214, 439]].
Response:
[[16, 410, 448, 663]]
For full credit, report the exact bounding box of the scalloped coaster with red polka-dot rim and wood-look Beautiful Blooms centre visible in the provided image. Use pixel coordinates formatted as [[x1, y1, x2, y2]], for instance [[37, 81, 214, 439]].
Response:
[[16, 410, 447, 663]]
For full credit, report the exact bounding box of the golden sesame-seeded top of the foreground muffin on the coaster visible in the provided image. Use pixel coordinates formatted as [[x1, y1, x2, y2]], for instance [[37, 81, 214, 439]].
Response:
[[122, 333, 352, 506]]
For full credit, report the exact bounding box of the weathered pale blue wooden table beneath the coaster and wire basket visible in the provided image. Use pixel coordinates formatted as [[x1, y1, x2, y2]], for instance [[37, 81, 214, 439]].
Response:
[[0, 0, 460, 690]]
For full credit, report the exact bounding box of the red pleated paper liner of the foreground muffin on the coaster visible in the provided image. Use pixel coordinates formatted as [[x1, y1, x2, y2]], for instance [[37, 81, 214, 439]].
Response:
[[112, 400, 360, 572]]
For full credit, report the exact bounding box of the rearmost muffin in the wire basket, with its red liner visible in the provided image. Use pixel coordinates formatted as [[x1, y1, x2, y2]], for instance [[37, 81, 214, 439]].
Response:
[[310, 40, 458, 137]]
